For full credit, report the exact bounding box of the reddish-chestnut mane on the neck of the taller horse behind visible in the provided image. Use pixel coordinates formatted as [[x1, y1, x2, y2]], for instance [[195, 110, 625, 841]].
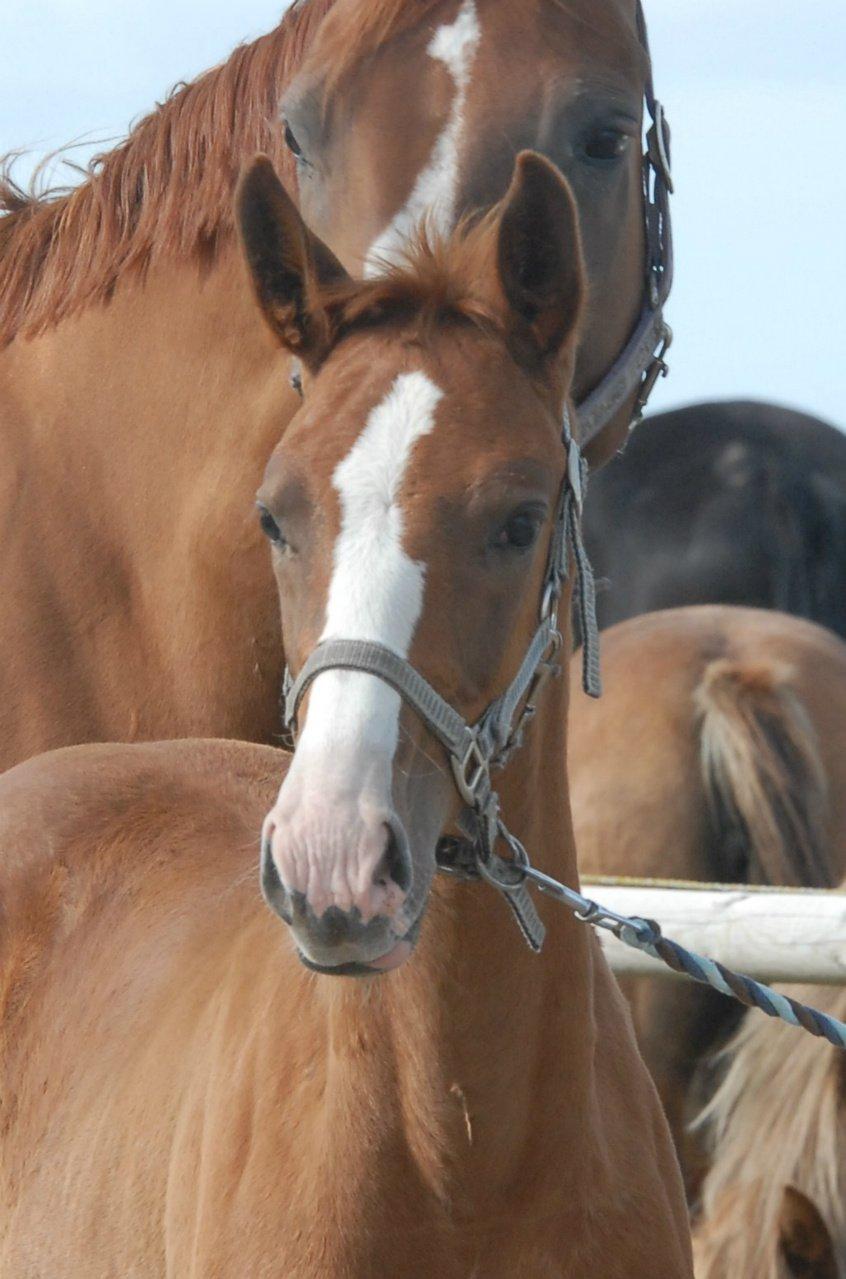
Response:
[[0, 0, 334, 347]]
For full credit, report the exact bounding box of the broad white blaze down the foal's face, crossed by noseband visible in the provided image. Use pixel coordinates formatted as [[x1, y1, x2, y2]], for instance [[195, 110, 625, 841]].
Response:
[[289, 372, 443, 767]]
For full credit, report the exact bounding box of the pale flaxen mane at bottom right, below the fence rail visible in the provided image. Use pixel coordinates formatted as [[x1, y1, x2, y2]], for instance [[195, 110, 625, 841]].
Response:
[[696, 986, 846, 1279]]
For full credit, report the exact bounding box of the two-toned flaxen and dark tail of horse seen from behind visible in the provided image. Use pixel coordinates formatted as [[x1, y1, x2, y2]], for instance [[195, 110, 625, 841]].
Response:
[[694, 659, 836, 888]]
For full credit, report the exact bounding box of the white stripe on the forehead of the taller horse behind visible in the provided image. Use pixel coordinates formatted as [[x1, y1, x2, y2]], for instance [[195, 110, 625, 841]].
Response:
[[365, 0, 481, 276]]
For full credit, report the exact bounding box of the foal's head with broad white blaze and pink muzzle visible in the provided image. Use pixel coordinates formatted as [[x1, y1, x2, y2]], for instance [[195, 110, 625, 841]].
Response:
[[238, 153, 584, 972]]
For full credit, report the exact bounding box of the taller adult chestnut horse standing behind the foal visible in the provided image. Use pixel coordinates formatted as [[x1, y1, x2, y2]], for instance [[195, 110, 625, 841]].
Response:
[[0, 0, 669, 764]]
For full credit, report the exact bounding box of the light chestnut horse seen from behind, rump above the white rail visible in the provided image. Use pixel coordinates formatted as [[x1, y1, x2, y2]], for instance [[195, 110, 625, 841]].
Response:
[[570, 605, 846, 1192]]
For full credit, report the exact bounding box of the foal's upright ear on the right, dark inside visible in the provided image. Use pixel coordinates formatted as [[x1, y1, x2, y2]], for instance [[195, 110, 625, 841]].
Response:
[[497, 151, 585, 370]]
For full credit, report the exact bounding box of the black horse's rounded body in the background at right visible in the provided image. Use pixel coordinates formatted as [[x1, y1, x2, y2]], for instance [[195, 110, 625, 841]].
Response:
[[584, 402, 846, 637]]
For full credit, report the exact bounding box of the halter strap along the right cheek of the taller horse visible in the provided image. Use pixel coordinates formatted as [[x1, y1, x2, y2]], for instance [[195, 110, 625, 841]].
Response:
[[577, 0, 673, 448]]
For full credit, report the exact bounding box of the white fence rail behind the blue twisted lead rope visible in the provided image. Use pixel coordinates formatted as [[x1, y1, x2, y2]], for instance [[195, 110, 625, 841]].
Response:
[[581, 879, 846, 985]]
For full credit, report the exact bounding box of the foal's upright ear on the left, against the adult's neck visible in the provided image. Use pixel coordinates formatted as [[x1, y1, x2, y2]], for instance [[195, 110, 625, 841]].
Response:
[[235, 156, 348, 367]]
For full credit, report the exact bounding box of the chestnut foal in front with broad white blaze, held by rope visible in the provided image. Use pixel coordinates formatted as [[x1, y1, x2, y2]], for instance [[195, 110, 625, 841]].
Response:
[[0, 153, 692, 1279]]
